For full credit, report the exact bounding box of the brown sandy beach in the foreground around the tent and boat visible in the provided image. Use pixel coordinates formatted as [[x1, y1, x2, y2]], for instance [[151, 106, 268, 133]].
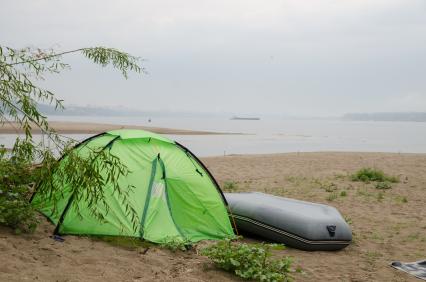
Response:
[[0, 153, 426, 281]]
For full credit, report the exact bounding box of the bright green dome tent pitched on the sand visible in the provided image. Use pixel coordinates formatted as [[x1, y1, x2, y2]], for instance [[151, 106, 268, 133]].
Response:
[[32, 130, 234, 243]]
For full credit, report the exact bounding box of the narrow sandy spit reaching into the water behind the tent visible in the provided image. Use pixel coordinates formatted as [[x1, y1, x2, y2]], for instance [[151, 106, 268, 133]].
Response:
[[0, 121, 242, 135]]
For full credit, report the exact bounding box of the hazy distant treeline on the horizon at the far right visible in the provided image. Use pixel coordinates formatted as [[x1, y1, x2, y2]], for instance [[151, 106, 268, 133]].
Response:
[[343, 112, 426, 121]]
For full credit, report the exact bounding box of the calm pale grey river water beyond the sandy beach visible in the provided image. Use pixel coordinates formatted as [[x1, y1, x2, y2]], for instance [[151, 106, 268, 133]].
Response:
[[0, 116, 426, 156]]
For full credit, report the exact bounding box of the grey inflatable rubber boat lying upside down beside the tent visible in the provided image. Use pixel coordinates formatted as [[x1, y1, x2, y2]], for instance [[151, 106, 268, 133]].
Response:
[[225, 192, 352, 251]]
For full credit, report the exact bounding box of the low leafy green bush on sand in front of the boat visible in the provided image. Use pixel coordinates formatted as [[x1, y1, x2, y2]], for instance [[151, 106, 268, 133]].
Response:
[[201, 240, 292, 281]]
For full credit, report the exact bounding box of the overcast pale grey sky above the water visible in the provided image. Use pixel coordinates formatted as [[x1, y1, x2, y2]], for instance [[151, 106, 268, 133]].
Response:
[[0, 0, 426, 116]]
